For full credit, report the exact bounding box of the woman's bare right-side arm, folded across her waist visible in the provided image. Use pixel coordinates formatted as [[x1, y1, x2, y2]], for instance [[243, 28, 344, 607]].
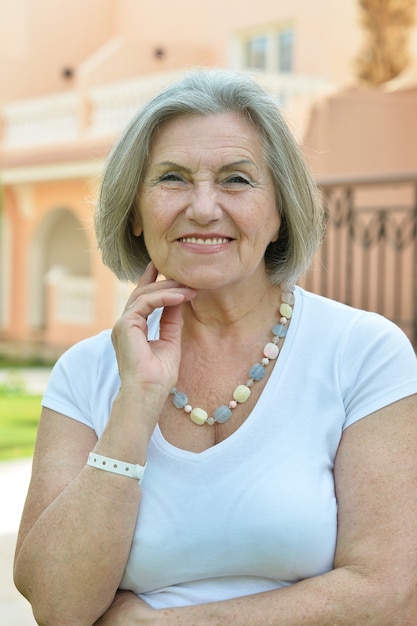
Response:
[[98, 396, 417, 626]]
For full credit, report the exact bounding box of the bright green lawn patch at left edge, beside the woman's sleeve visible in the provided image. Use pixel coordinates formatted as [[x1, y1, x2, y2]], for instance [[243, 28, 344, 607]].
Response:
[[0, 393, 41, 461]]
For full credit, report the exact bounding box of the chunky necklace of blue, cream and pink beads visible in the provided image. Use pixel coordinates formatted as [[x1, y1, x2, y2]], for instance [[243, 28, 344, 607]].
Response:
[[170, 286, 295, 426]]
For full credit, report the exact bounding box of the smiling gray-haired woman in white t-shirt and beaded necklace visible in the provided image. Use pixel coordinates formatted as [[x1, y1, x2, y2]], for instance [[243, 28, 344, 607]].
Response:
[[15, 70, 417, 626]]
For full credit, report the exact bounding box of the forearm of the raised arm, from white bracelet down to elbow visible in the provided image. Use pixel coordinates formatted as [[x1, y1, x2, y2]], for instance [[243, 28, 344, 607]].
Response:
[[15, 468, 139, 626]]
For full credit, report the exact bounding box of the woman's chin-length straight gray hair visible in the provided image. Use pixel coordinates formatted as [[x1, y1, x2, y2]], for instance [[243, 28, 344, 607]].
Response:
[[95, 70, 324, 284]]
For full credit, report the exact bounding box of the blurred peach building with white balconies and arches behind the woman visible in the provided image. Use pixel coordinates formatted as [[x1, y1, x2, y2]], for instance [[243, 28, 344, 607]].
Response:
[[0, 0, 417, 350]]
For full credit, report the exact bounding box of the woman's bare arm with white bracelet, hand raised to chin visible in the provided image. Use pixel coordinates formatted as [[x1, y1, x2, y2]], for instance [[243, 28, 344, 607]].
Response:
[[15, 266, 194, 626]]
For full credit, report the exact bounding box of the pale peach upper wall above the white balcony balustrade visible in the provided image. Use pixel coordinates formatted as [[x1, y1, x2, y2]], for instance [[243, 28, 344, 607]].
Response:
[[0, 0, 362, 102]]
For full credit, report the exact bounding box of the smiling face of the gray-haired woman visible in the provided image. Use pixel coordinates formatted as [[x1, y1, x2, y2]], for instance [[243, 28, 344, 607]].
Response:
[[133, 113, 280, 289]]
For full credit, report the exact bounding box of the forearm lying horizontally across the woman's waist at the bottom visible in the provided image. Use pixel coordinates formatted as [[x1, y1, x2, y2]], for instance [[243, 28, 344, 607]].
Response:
[[117, 568, 410, 626]]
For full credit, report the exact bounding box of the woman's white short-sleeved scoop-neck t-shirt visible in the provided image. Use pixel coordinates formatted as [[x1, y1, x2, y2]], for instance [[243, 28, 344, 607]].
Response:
[[43, 288, 417, 608]]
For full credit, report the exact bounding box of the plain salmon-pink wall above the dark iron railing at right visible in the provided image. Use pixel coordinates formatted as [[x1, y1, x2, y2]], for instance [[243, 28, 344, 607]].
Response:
[[304, 85, 417, 177]]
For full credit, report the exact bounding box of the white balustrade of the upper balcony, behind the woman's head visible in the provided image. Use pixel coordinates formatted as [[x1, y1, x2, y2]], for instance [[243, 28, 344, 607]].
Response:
[[0, 71, 329, 152]]
